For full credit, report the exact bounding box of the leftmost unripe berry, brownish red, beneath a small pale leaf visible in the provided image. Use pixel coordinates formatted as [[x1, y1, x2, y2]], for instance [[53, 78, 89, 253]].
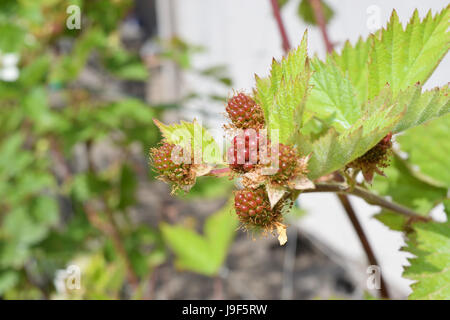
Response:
[[150, 142, 195, 188]]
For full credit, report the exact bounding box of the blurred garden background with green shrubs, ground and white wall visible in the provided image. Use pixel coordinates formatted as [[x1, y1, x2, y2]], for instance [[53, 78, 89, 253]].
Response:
[[0, 0, 450, 299]]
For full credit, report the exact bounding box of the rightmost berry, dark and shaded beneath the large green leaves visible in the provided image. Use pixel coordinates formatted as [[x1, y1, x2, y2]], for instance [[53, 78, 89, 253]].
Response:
[[347, 133, 392, 182]]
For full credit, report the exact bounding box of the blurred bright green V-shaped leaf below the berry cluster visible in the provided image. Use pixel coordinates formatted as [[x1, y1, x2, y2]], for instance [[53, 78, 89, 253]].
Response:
[[161, 201, 238, 276]]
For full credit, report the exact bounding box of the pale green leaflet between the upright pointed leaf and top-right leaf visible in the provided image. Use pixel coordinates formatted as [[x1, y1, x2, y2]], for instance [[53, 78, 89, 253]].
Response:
[[305, 59, 361, 131]]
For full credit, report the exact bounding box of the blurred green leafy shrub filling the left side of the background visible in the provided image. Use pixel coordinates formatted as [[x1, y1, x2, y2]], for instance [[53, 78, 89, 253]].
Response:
[[0, 0, 234, 299]]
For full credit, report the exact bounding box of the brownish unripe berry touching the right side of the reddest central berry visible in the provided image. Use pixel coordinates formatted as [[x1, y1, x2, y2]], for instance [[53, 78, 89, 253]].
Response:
[[269, 143, 305, 185]]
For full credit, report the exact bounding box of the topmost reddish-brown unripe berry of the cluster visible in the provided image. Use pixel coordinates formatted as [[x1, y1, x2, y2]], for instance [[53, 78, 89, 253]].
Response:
[[226, 93, 264, 129]]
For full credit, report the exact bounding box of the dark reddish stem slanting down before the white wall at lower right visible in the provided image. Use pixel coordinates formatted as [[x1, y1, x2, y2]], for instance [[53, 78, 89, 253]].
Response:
[[337, 193, 390, 299]]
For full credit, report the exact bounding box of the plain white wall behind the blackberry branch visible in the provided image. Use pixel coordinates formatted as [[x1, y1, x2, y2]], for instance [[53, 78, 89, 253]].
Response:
[[173, 0, 450, 294]]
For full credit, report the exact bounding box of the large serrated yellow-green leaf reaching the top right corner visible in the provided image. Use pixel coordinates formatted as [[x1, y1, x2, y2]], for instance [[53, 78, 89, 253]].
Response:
[[331, 7, 450, 103]]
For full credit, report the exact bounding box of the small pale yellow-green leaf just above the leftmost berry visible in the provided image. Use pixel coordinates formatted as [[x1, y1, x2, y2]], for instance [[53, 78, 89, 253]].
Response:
[[154, 119, 223, 164]]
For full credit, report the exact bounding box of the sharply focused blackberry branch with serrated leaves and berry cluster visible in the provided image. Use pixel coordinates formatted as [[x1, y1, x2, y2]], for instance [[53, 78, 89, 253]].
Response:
[[151, 5, 450, 299]]
